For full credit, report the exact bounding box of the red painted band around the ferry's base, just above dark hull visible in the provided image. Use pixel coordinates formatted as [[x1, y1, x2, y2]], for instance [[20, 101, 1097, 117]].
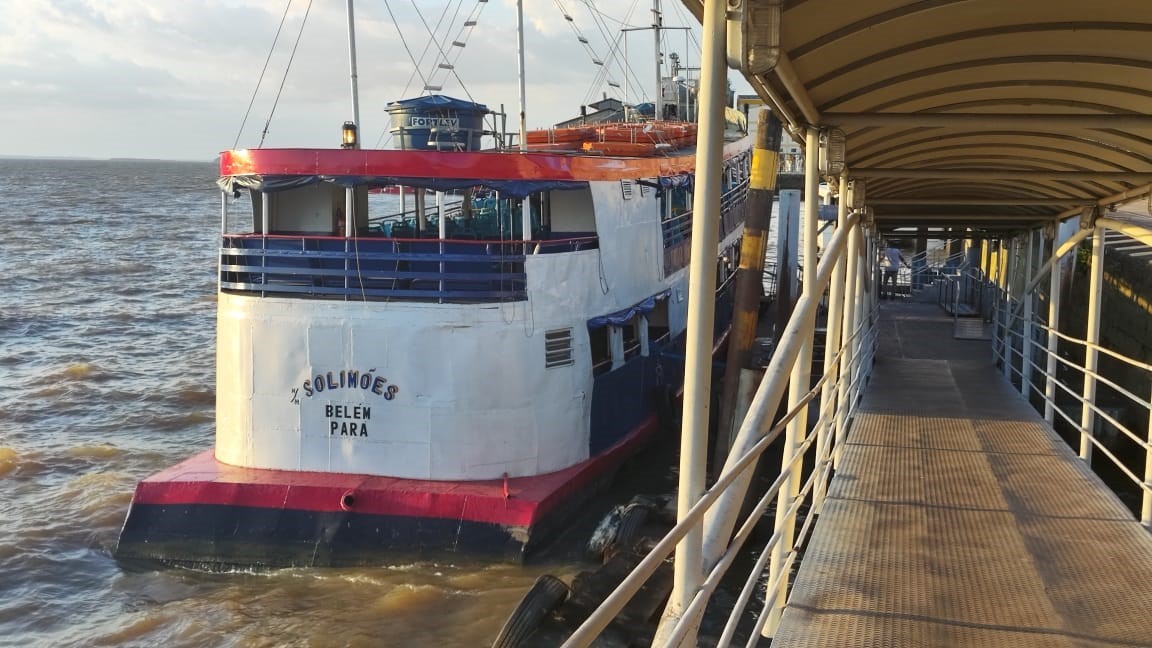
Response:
[[132, 415, 657, 527]]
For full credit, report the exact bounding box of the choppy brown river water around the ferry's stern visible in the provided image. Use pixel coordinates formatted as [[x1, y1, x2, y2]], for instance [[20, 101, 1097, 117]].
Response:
[[0, 160, 603, 647]]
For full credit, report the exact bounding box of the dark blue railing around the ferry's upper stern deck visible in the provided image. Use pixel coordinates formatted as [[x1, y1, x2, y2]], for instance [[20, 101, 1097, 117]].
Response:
[[220, 234, 597, 302]]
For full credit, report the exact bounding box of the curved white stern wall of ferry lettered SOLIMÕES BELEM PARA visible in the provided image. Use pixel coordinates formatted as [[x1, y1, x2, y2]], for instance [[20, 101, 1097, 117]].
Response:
[[215, 294, 592, 480]]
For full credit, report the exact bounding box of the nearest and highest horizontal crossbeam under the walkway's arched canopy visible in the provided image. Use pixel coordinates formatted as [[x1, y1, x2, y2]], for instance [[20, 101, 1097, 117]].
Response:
[[824, 112, 1152, 130]]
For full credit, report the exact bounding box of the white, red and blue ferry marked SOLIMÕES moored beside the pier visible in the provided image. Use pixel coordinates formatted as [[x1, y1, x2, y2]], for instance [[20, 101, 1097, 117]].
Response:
[[116, 8, 751, 568]]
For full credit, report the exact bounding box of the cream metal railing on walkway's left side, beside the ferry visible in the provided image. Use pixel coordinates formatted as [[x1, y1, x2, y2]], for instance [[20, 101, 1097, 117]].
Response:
[[563, 211, 879, 648]]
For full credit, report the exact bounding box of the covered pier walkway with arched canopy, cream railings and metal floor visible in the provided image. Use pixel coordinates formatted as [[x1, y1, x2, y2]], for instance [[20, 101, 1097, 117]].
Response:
[[546, 0, 1152, 647]]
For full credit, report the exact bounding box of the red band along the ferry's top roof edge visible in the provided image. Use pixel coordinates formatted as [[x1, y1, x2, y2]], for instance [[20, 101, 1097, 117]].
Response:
[[220, 140, 746, 181]]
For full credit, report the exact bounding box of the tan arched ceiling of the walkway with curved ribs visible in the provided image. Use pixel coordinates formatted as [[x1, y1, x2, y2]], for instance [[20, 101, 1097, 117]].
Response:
[[684, 0, 1152, 235]]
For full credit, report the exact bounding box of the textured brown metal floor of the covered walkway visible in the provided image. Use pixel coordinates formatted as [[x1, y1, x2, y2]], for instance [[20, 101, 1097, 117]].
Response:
[[772, 307, 1152, 648]]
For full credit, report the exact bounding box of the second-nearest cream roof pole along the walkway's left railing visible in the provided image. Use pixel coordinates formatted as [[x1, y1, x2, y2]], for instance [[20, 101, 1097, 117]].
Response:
[[764, 123, 820, 636]]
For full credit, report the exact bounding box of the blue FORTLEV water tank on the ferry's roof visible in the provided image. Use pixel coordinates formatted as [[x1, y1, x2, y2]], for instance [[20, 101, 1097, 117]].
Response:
[[387, 95, 488, 151]]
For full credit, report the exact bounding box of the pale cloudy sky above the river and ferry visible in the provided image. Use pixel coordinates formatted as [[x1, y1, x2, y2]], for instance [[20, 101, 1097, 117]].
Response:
[[0, 0, 746, 160]]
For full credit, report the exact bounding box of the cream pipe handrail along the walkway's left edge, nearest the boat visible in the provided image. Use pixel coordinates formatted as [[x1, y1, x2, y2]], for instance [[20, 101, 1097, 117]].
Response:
[[564, 214, 879, 647]]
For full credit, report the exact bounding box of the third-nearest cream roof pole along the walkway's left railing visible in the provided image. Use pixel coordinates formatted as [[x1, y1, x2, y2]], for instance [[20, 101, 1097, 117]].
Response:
[[812, 172, 848, 513]]
